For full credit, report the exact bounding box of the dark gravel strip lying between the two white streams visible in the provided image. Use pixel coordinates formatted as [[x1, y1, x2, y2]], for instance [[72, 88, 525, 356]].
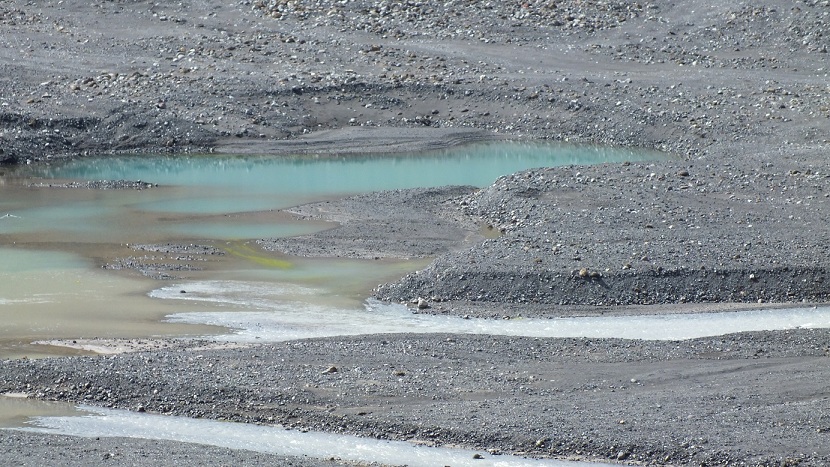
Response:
[[0, 330, 830, 466]]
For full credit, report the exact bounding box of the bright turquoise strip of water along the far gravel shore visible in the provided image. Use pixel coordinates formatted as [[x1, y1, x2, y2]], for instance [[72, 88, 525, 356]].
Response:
[[17, 143, 666, 214]]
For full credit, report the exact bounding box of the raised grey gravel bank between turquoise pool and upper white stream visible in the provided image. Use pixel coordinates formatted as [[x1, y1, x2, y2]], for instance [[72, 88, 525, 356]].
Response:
[[375, 162, 830, 306]]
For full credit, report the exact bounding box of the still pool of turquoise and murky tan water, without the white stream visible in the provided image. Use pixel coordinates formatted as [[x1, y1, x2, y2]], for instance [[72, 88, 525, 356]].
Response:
[[0, 143, 665, 358]]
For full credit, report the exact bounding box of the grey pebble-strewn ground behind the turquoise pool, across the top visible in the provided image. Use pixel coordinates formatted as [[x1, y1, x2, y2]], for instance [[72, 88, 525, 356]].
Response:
[[0, 0, 830, 165]]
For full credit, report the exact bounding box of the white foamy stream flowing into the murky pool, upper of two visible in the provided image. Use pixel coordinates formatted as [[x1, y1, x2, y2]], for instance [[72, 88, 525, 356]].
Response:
[[150, 281, 830, 342]]
